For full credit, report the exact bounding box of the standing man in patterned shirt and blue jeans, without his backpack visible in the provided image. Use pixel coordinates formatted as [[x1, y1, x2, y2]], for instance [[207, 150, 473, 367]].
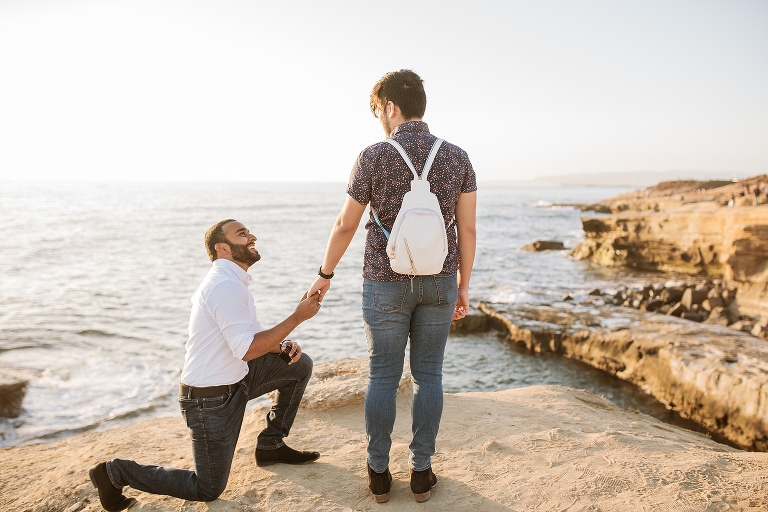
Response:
[[308, 70, 477, 503]]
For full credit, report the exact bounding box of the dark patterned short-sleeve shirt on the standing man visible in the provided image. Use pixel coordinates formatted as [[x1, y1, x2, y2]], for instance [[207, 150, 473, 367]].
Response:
[[347, 121, 477, 281]]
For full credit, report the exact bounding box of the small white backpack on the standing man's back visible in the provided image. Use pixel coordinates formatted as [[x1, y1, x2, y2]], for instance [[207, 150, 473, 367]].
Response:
[[373, 139, 448, 276]]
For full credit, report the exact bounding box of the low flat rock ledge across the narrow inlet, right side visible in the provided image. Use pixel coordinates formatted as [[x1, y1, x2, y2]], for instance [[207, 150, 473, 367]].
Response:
[[479, 303, 768, 452]]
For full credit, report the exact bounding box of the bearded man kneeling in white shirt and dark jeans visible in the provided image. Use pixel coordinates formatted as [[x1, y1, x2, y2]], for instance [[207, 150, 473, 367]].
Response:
[[90, 219, 320, 511]]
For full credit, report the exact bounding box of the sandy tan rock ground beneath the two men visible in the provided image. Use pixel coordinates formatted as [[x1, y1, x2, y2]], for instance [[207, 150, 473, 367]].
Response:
[[0, 359, 768, 512]]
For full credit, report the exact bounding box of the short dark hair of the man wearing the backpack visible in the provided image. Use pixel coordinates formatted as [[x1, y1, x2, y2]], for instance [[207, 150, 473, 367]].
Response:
[[370, 69, 427, 119]]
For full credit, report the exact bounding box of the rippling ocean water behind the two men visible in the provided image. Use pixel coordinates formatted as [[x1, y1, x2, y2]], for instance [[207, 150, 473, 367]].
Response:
[[0, 182, 696, 446]]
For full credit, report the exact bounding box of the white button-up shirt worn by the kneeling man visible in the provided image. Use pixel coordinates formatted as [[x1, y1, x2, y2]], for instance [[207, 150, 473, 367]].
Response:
[[181, 258, 264, 387]]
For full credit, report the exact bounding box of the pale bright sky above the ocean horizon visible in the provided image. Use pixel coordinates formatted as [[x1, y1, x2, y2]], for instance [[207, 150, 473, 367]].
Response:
[[0, 0, 768, 181]]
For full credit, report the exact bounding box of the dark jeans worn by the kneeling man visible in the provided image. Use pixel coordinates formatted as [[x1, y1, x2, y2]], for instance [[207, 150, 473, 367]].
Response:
[[107, 354, 312, 501]]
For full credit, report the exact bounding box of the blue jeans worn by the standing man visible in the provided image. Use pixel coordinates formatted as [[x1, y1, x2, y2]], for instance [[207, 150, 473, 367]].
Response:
[[363, 275, 458, 473]]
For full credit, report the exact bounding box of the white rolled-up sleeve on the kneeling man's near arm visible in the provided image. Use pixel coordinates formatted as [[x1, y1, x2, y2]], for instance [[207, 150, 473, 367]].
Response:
[[208, 281, 261, 359]]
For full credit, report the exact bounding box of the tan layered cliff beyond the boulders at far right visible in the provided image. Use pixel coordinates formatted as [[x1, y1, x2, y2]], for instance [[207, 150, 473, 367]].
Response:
[[571, 175, 768, 319]]
